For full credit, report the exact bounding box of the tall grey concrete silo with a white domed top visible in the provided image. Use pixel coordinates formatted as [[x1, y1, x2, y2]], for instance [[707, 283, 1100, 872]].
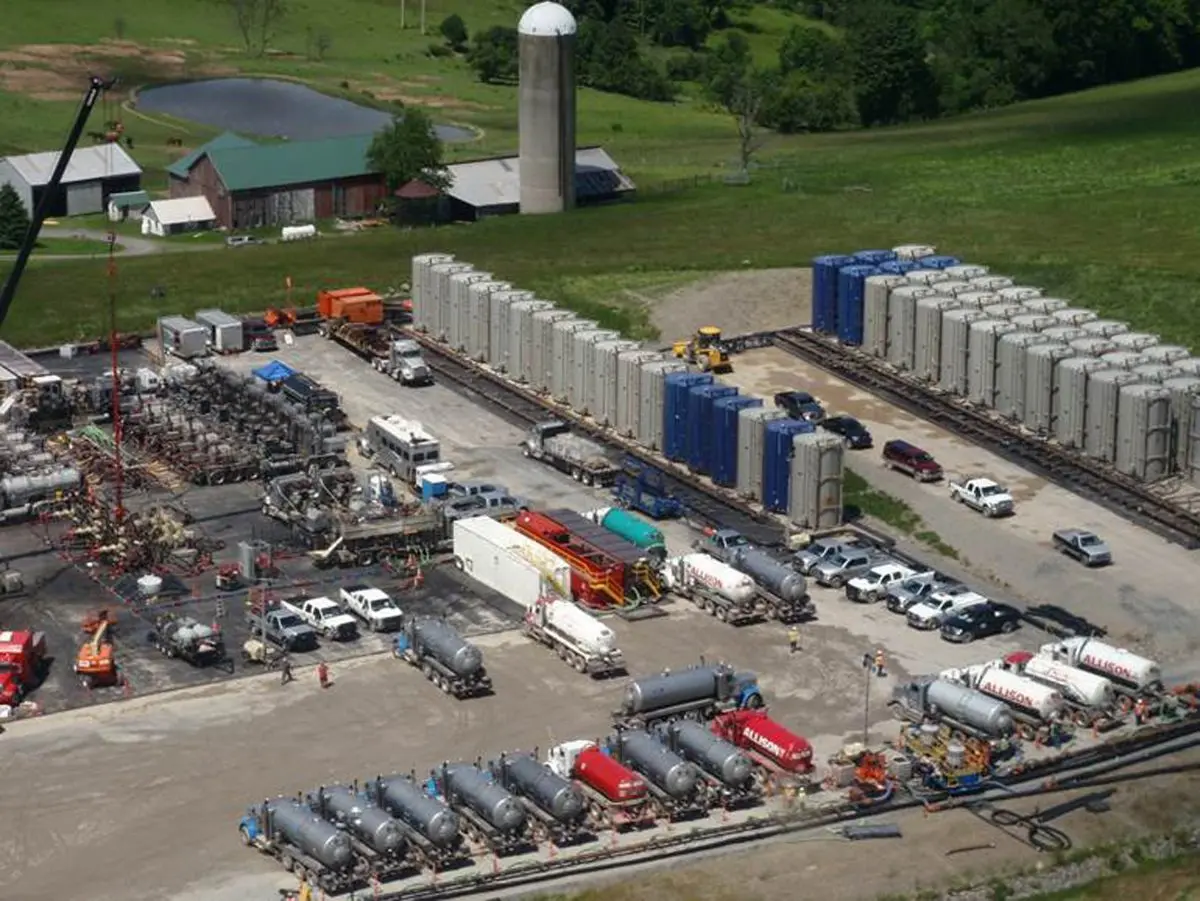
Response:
[[517, 2, 576, 214]]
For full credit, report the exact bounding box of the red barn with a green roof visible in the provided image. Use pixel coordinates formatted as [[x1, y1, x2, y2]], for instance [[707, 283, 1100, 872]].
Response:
[[167, 133, 388, 229]]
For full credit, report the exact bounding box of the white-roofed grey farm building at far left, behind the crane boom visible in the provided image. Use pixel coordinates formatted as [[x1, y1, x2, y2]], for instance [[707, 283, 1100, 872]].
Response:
[[0, 142, 142, 216]]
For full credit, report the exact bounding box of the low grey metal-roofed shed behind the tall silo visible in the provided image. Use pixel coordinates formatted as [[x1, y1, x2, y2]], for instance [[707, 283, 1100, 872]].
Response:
[[446, 146, 636, 220]]
